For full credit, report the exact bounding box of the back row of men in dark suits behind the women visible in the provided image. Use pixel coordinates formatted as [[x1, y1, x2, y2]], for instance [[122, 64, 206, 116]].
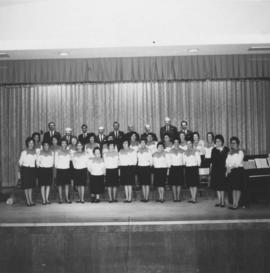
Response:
[[43, 117, 192, 145]]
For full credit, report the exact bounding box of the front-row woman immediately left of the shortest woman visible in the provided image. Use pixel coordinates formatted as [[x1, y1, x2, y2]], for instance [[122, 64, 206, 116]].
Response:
[[72, 141, 88, 204]]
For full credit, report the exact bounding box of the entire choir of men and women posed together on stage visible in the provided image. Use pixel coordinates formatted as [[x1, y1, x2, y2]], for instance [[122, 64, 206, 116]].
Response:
[[19, 118, 244, 209]]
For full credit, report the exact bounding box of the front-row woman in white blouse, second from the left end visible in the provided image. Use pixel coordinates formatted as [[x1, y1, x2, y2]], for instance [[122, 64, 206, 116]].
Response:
[[37, 141, 54, 205]]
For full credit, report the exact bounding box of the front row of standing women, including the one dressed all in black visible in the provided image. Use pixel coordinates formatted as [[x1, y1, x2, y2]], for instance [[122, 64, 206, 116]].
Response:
[[19, 135, 244, 209]]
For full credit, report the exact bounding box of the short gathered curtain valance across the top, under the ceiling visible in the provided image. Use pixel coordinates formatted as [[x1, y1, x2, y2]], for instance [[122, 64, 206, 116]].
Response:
[[0, 54, 270, 85]]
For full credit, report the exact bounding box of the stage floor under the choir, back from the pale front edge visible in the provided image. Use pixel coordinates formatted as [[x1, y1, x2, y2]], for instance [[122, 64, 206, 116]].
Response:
[[0, 197, 270, 223]]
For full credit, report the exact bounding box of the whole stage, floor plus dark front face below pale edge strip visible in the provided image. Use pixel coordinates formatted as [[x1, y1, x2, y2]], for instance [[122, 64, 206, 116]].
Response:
[[0, 193, 270, 273]]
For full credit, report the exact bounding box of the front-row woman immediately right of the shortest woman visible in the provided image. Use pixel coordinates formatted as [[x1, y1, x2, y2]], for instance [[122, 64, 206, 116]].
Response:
[[103, 142, 119, 203]]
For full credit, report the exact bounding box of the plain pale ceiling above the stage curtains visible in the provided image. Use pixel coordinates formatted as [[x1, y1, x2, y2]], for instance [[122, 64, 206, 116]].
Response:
[[0, 0, 270, 60]]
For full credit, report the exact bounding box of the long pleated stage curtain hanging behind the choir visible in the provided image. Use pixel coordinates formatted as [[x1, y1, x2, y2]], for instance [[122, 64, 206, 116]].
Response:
[[0, 80, 270, 186]]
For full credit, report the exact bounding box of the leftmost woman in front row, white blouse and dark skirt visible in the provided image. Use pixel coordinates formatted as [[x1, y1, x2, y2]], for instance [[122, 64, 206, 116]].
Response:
[[19, 137, 37, 207]]
